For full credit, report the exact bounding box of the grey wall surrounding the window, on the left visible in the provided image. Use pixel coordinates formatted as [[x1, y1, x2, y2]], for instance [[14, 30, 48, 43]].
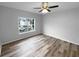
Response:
[[0, 6, 42, 44]]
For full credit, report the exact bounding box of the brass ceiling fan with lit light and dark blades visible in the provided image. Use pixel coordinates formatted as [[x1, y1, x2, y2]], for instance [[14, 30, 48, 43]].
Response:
[[34, 2, 59, 13]]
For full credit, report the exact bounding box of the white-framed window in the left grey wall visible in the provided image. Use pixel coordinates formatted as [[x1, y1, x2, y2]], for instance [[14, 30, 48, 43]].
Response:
[[19, 17, 35, 33]]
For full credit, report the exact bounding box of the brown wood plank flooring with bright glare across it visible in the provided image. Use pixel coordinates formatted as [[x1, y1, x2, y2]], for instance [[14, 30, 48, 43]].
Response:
[[2, 35, 79, 57]]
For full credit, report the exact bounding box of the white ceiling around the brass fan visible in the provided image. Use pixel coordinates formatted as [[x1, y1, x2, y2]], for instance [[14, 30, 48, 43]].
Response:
[[0, 2, 79, 13]]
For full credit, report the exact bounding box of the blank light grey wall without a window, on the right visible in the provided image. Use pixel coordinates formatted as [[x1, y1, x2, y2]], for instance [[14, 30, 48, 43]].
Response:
[[43, 8, 79, 45]]
